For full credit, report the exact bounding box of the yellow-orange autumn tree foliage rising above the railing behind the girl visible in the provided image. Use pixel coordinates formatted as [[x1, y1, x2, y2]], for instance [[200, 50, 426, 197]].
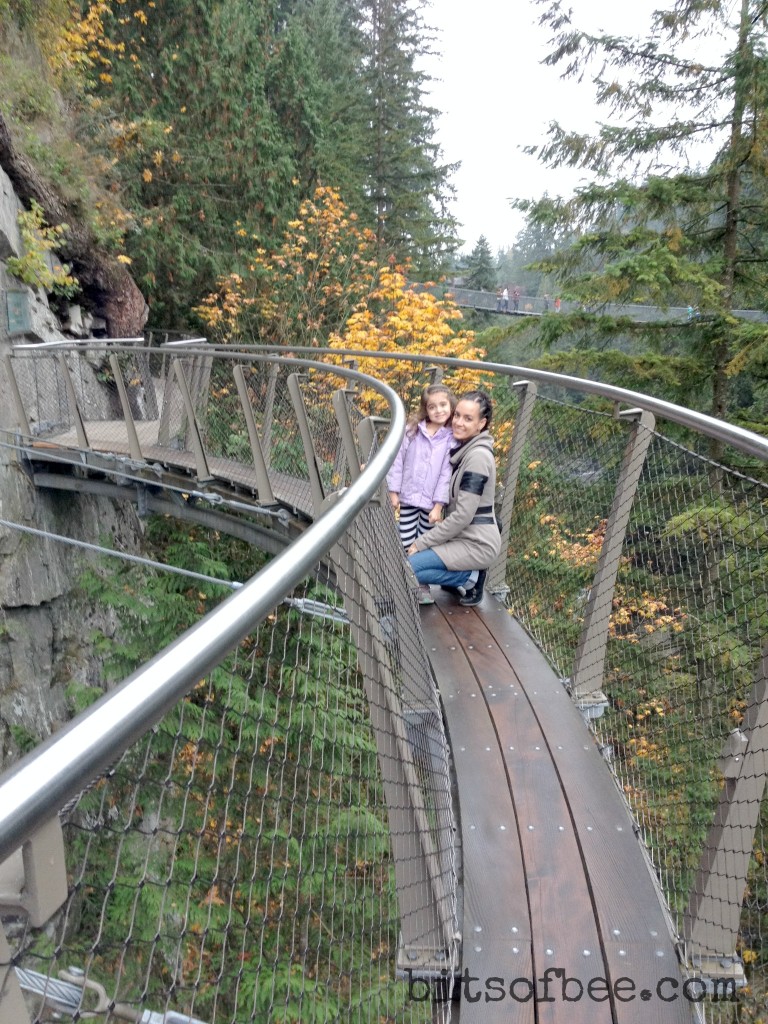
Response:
[[195, 185, 485, 398]]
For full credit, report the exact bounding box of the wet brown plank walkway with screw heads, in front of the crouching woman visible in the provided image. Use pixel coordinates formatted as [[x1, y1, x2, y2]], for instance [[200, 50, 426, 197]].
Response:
[[422, 588, 696, 1024]]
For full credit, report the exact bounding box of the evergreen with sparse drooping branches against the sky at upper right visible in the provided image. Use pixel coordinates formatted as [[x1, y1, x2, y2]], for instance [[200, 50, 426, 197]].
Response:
[[519, 0, 768, 417]]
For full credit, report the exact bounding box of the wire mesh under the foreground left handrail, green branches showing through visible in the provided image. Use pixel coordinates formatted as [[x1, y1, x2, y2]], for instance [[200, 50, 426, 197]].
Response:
[[6, 516, 456, 1024]]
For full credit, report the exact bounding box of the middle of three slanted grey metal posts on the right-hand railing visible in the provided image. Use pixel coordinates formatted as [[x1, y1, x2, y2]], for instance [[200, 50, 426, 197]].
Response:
[[571, 409, 655, 700]]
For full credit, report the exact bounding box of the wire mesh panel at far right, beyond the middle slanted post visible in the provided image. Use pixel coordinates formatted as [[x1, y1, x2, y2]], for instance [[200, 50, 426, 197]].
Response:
[[595, 435, 768, 1006]]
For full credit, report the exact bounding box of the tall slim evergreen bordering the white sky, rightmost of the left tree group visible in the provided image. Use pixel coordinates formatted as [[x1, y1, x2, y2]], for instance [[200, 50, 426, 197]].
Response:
[[357, 0, 457, 275]]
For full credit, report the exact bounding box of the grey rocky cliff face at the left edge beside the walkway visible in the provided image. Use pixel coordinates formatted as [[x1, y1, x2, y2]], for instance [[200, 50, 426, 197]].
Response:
[[0, 161, 141, 768]]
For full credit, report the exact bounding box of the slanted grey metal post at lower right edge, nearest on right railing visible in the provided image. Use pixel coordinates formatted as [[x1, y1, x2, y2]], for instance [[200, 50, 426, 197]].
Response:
[[683, 647, 768, 973]]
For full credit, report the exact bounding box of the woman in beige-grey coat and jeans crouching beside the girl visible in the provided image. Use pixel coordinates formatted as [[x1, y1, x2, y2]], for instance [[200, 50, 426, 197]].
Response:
[[408, 391, 501, 607]]
